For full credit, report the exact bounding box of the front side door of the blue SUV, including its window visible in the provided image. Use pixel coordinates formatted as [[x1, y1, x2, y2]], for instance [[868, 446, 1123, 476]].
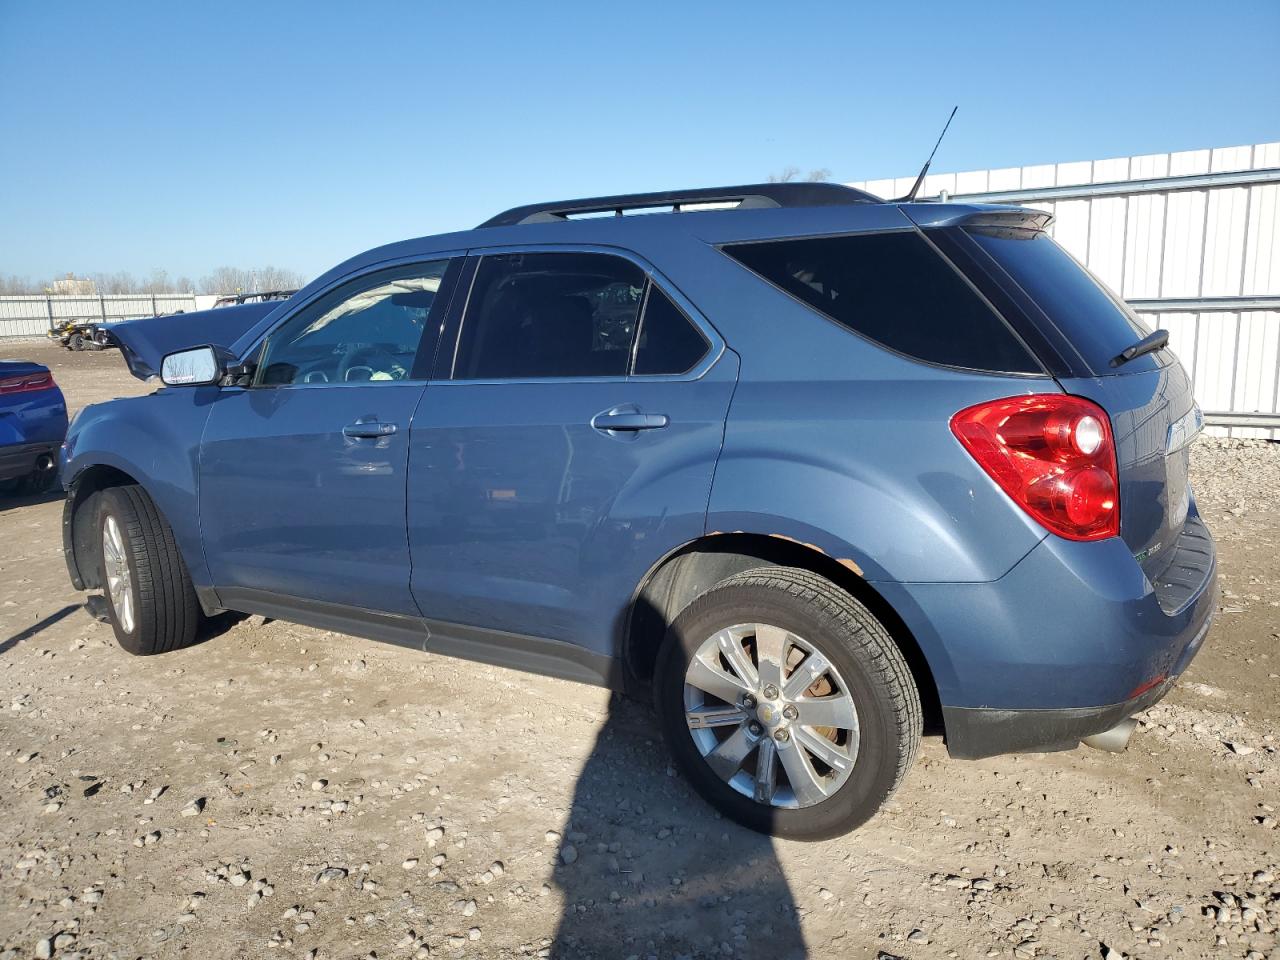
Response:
[[200, 260, 453, 616]]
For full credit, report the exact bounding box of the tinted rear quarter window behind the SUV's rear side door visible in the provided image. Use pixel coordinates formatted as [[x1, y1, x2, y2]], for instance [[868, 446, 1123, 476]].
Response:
[[726, 233, 1041, 372]]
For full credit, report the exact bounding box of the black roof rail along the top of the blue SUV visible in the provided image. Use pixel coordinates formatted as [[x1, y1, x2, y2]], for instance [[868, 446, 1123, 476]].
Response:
[[480, 183, 882, 227]]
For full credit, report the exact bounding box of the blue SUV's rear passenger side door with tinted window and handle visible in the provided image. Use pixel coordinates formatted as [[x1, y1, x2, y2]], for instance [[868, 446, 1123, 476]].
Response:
[[408, 250, 737, 662]]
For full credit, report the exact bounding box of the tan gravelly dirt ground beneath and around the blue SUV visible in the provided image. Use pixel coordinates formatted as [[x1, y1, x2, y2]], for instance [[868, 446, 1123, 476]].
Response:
[[0, 344, 1280, 960]]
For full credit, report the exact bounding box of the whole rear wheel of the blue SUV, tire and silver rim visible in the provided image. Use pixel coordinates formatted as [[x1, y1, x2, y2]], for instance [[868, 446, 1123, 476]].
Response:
[[654, 567, 922, 840]]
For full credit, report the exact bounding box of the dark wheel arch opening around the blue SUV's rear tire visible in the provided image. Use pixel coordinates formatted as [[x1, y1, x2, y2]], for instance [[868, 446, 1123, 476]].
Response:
[[621, 531, 942, 732]]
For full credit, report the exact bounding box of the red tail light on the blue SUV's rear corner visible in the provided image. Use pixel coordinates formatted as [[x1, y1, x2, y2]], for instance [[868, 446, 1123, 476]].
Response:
[[951, 393, 1120, 540]]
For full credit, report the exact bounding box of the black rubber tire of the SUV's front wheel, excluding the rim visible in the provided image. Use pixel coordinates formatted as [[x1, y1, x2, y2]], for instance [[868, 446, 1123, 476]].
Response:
[[97, 484, 204, 657]]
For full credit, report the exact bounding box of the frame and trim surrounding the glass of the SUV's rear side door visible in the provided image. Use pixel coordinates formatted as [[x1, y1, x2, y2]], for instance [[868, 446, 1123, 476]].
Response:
[[431, 243, 726, 384]]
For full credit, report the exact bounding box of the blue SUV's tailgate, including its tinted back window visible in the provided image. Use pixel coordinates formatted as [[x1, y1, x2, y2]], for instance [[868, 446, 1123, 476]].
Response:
[[965, 227, 1201, 581]]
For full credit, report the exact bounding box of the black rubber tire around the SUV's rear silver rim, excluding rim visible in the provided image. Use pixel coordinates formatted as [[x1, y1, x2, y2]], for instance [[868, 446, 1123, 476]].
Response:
[[654, 567, 922, 840]]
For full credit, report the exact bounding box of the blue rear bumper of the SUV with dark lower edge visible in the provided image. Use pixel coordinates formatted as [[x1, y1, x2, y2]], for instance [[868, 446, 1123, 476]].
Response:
[[877, 511, 1217, 758]]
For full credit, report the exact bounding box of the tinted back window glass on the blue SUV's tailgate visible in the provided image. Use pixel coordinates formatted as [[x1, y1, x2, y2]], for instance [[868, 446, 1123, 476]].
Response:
[[969, 228, 1155, 374]]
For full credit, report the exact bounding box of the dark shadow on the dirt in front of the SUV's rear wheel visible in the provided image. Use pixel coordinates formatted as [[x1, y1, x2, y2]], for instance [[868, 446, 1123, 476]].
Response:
[[550, 695, 806, 960]]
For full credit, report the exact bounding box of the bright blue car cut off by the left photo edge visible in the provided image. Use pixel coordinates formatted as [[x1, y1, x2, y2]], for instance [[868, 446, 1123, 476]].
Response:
[[0, 360, 67, 493]]
